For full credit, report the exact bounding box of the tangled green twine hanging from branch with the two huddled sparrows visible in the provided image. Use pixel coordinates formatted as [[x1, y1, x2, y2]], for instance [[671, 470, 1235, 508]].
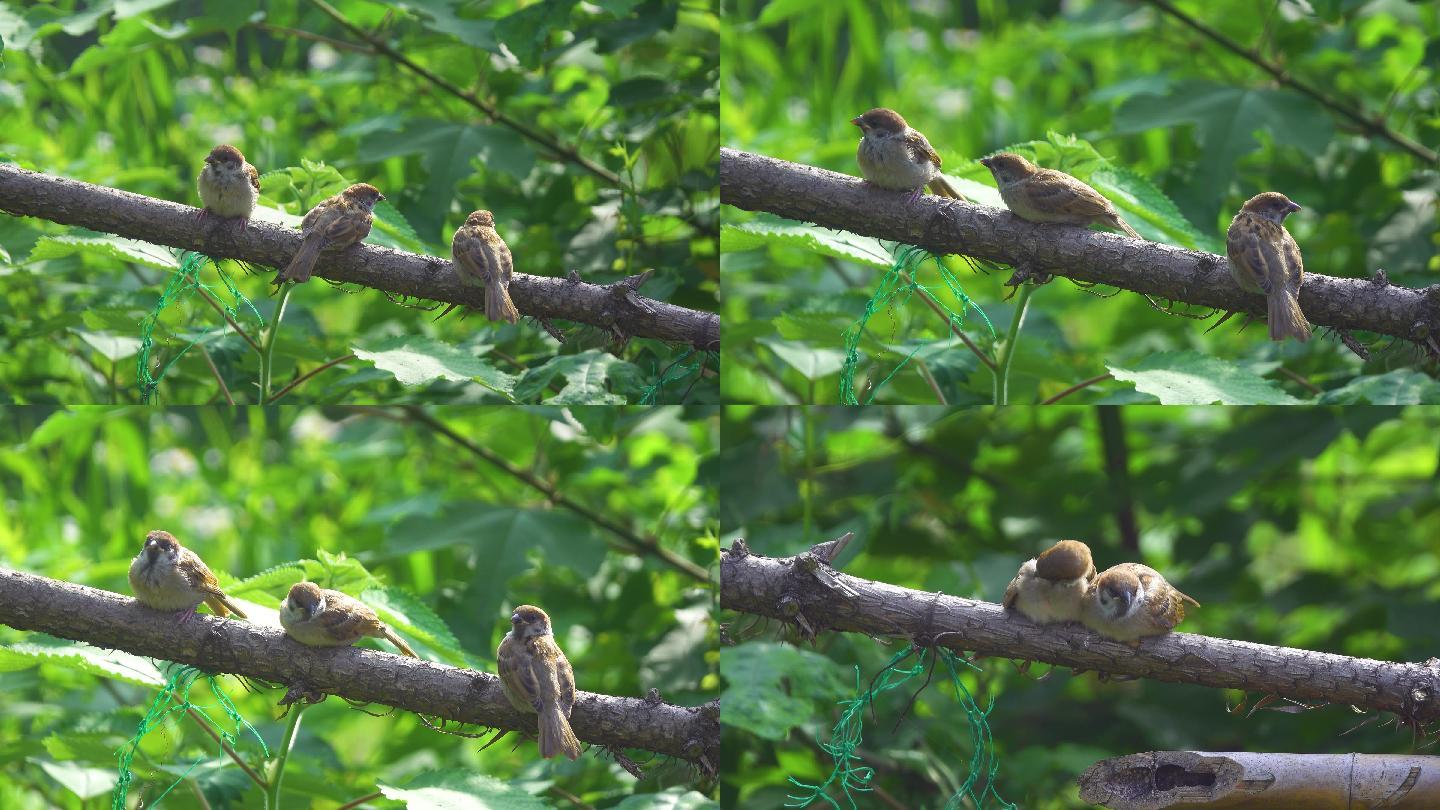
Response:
[[785, 646, 1017, 810]]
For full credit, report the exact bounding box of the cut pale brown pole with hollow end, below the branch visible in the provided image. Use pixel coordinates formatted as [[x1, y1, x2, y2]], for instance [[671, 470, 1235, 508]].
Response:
[[1080, 751, 1440, 810]]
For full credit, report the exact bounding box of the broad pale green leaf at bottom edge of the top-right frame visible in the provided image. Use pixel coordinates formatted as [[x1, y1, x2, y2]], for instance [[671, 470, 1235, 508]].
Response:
[[1107, 352, 1303, 405]]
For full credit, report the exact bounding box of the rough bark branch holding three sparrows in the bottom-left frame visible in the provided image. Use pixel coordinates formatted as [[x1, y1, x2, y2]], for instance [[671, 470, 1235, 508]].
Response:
[[0, 568, 720, 774]]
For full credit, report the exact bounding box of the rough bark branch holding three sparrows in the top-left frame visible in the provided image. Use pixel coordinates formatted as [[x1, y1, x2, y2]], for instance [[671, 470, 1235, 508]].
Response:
[[0, 164, 720, 350]]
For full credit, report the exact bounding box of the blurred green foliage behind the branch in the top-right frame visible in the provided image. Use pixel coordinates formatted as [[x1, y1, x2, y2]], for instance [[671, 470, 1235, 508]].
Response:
[[720, 0, 1440, 405]]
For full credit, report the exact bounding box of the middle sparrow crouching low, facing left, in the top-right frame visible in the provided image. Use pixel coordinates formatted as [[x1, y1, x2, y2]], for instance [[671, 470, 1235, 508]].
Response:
[[981, 151, 1140, 239]]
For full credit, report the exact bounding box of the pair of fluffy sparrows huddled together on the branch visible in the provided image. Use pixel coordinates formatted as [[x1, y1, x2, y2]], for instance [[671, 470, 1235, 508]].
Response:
[[1004, 540, 1200, 647]]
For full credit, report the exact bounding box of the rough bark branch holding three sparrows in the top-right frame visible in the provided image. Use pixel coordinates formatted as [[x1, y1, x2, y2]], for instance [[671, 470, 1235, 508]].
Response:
[[720, 148, 1440, 352]]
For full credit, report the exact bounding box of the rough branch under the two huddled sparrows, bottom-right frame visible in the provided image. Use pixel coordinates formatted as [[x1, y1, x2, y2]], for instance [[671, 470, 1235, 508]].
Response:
[[720, 540, 1440, 725]]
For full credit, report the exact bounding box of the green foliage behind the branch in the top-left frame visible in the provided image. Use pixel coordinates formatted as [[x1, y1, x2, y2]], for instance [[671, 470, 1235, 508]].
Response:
[[0, 0, 719, 404]]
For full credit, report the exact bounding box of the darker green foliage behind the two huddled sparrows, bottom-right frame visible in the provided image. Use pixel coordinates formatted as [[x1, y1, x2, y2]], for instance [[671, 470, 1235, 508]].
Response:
[[717, 406, 1440, 810]]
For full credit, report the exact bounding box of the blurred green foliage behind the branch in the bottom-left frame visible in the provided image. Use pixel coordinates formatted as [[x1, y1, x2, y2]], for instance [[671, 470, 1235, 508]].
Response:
[[0, 406, 719, 810]]
